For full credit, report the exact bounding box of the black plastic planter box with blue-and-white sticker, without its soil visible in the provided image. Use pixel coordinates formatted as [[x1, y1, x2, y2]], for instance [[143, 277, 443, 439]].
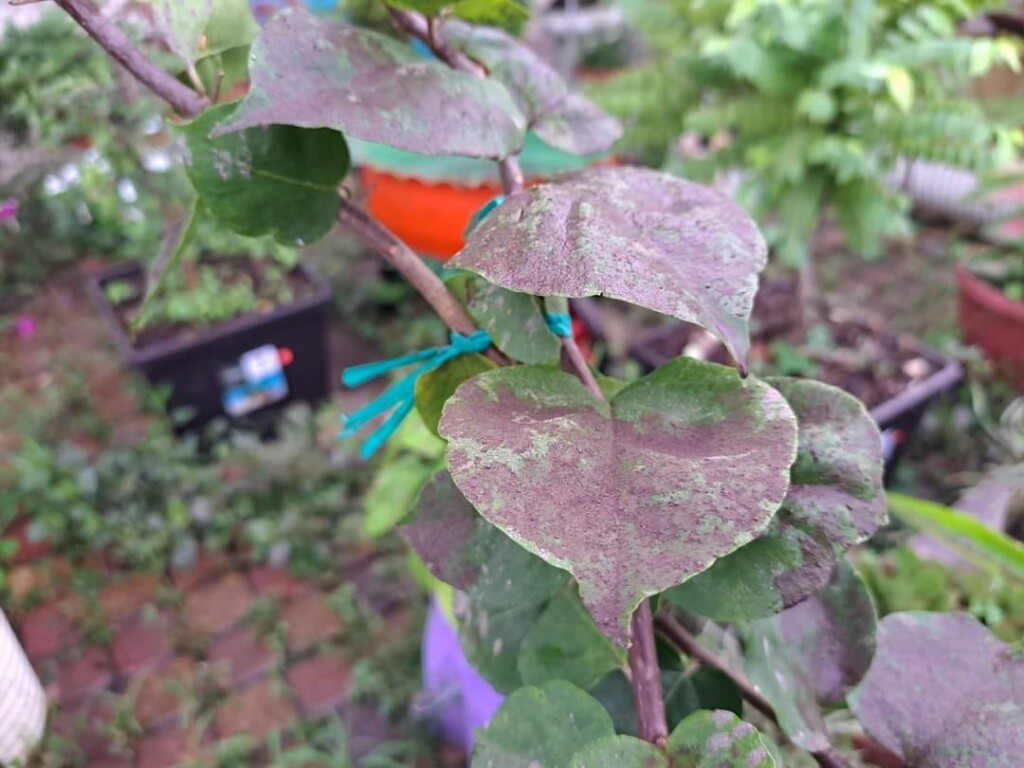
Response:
[[87, 262, 331, 433]]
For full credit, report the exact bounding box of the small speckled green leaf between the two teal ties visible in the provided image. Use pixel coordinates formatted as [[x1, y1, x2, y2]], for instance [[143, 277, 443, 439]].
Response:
[[466, 276, 561, 366]]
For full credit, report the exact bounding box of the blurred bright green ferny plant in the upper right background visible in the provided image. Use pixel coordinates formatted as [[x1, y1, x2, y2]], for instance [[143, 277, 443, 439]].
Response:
[[595, 0, 1020, 265]]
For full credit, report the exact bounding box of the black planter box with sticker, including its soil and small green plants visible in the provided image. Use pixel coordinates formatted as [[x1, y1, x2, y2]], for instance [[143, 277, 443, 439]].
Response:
[[88, 246, 331, 431]]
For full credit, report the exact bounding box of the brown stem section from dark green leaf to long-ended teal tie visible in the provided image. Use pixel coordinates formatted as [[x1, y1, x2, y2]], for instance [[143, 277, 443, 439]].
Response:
[[338, 198, 510, 366]]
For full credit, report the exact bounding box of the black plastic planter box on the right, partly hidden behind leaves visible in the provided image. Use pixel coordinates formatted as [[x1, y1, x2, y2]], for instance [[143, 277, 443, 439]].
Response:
[[630, 324, 964, 482]]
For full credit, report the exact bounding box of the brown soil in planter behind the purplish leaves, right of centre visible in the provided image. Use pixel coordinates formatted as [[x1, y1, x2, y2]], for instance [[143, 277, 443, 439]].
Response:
[[636, 281, 940, 415]]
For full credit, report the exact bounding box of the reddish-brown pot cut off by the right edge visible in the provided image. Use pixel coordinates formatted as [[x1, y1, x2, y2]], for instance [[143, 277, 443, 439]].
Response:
[[956, 264, 1024, 388]]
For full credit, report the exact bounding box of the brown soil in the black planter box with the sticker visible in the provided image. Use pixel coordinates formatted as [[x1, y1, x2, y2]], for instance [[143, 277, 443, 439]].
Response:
[[104, 257, 315, 349]]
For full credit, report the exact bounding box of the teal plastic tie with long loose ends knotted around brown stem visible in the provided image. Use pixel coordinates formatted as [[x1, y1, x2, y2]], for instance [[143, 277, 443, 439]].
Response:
[[338, 331, 490, 459]]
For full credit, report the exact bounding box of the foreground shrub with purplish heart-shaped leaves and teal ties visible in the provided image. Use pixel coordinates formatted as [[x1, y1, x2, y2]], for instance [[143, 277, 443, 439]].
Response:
[[37, 0, 1024, 768]]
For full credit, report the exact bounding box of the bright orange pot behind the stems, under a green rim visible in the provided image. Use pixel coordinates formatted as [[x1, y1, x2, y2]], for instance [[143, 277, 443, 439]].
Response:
[[361, 167, 502, 260]]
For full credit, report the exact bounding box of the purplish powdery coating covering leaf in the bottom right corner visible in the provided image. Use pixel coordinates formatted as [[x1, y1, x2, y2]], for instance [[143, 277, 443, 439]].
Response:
[[849, 612, 1024, 768]]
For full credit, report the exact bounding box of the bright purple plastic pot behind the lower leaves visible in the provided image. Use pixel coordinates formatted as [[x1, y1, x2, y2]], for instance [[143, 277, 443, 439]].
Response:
[[423, 600, 504, 755]]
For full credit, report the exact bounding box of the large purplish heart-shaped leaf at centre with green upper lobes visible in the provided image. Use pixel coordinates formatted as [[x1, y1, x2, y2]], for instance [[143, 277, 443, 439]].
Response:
[[440, 358, 797, 645]]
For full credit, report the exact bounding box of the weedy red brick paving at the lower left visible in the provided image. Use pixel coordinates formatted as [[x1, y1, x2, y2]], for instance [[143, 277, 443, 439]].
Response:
[[4, 550, 430, 768]]
